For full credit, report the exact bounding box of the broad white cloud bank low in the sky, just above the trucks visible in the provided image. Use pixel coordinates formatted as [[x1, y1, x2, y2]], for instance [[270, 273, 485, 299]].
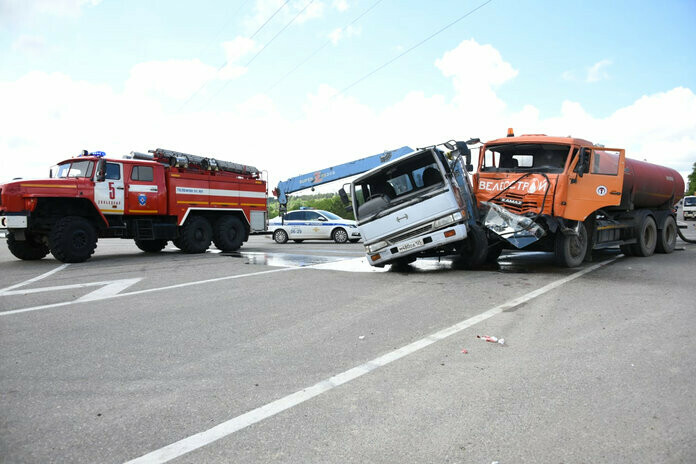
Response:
[[0, 40, 696, 187]]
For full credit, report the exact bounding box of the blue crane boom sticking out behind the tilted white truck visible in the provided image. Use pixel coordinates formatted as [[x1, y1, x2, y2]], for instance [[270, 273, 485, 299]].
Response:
[[273, 146, 413, 208]]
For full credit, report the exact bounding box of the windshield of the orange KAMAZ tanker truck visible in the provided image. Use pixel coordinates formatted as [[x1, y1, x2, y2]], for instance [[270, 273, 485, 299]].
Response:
[[481, 143, 570, 173]]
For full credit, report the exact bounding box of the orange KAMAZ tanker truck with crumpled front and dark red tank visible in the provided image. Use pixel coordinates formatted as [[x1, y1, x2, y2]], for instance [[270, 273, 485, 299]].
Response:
[[474, 129, 684, 267]]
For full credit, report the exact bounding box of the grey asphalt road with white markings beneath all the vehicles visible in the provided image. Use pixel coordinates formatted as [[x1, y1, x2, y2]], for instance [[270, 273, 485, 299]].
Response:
[[0, 223, 696, 464]]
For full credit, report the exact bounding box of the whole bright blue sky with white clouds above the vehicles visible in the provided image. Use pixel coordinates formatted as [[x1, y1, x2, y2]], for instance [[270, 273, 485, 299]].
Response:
[[0, 0, 696, 191]]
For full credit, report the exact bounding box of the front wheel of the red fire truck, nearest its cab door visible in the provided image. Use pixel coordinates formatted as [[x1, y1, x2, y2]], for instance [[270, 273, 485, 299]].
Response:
[[49, 216, 97, 263]]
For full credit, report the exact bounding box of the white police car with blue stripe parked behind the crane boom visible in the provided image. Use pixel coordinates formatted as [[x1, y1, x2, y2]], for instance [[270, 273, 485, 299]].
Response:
[[268, 209, 360, 243]]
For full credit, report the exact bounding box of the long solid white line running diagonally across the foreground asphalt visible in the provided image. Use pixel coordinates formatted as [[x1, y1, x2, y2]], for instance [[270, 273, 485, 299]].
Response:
[[126, 256, 620, 464]]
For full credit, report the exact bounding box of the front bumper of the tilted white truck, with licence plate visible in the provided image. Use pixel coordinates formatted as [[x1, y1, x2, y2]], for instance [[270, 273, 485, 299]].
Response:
[[367, 224, 467, 267]]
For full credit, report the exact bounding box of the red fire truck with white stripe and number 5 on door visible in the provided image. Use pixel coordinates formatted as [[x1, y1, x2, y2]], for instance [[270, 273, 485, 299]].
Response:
[[0, 148, 268, 263]]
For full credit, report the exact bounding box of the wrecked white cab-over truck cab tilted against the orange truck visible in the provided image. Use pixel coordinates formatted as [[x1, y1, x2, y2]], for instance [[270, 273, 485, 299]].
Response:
[[339, 140, 487, 267]]
